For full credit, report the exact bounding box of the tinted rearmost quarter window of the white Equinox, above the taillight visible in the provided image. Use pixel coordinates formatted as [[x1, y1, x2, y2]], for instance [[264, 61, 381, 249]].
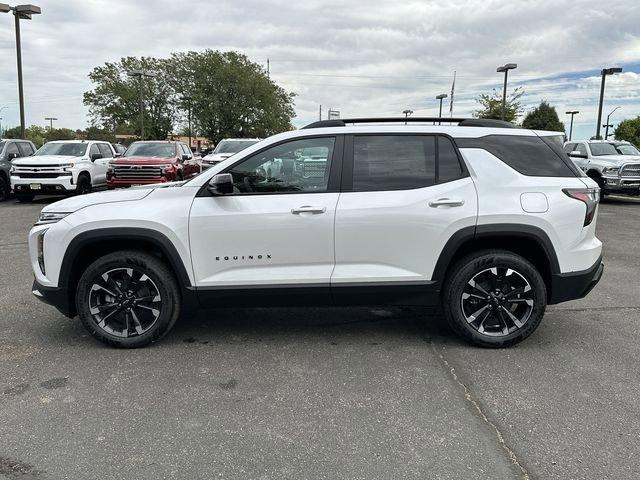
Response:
[[456, 135, 578, 177]]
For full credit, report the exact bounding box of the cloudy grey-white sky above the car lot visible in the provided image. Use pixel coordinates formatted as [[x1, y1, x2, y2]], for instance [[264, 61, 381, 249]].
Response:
[[0, 0, 640, 139]]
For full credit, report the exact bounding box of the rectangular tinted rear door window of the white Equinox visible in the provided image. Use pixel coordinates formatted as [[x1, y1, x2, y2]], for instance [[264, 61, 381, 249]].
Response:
[[353, 135, 436, 192]]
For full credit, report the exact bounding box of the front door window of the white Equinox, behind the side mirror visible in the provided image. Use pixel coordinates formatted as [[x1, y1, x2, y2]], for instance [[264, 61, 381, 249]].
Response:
[[227, 137, 335, 194]]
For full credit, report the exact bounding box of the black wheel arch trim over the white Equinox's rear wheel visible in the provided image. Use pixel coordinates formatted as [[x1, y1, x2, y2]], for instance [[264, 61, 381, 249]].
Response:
[[432, 223, 560, 284]]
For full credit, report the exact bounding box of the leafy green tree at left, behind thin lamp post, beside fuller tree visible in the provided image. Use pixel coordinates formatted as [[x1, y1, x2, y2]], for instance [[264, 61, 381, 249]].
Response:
[[83, 57, 176, 140]]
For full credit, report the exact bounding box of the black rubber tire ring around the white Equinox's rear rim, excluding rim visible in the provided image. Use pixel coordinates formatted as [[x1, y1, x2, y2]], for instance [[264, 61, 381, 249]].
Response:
[[444, 251, 547, 347]]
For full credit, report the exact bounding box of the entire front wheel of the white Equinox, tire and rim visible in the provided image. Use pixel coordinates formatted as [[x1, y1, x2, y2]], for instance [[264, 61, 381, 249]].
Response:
[[76, 250, 181, 348]]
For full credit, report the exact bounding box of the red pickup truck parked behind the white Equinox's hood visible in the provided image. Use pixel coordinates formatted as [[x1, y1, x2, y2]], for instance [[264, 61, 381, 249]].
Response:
[[107, 141, 202, 189]]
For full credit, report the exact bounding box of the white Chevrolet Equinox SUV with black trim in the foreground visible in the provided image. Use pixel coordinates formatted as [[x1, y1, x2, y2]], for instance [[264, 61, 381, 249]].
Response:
[[29, 118, 603, 347]]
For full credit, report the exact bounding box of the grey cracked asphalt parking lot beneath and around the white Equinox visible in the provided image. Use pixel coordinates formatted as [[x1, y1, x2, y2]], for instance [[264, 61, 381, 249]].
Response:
[[0, 193, 640, 480]]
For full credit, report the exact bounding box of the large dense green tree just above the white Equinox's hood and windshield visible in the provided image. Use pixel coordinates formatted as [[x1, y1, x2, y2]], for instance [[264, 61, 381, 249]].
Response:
[[167, 50, 295, 143]]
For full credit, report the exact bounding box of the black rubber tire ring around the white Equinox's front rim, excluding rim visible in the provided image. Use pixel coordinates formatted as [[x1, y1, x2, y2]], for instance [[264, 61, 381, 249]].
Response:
[[76, 252, 181, 348]]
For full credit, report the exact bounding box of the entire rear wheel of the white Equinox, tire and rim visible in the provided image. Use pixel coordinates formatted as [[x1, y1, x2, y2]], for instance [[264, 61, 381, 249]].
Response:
[[442, 250, 547, 348]]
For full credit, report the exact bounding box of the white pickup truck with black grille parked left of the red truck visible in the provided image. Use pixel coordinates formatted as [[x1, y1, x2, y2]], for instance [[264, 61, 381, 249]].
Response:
[[11, 140, 115, 202]]
